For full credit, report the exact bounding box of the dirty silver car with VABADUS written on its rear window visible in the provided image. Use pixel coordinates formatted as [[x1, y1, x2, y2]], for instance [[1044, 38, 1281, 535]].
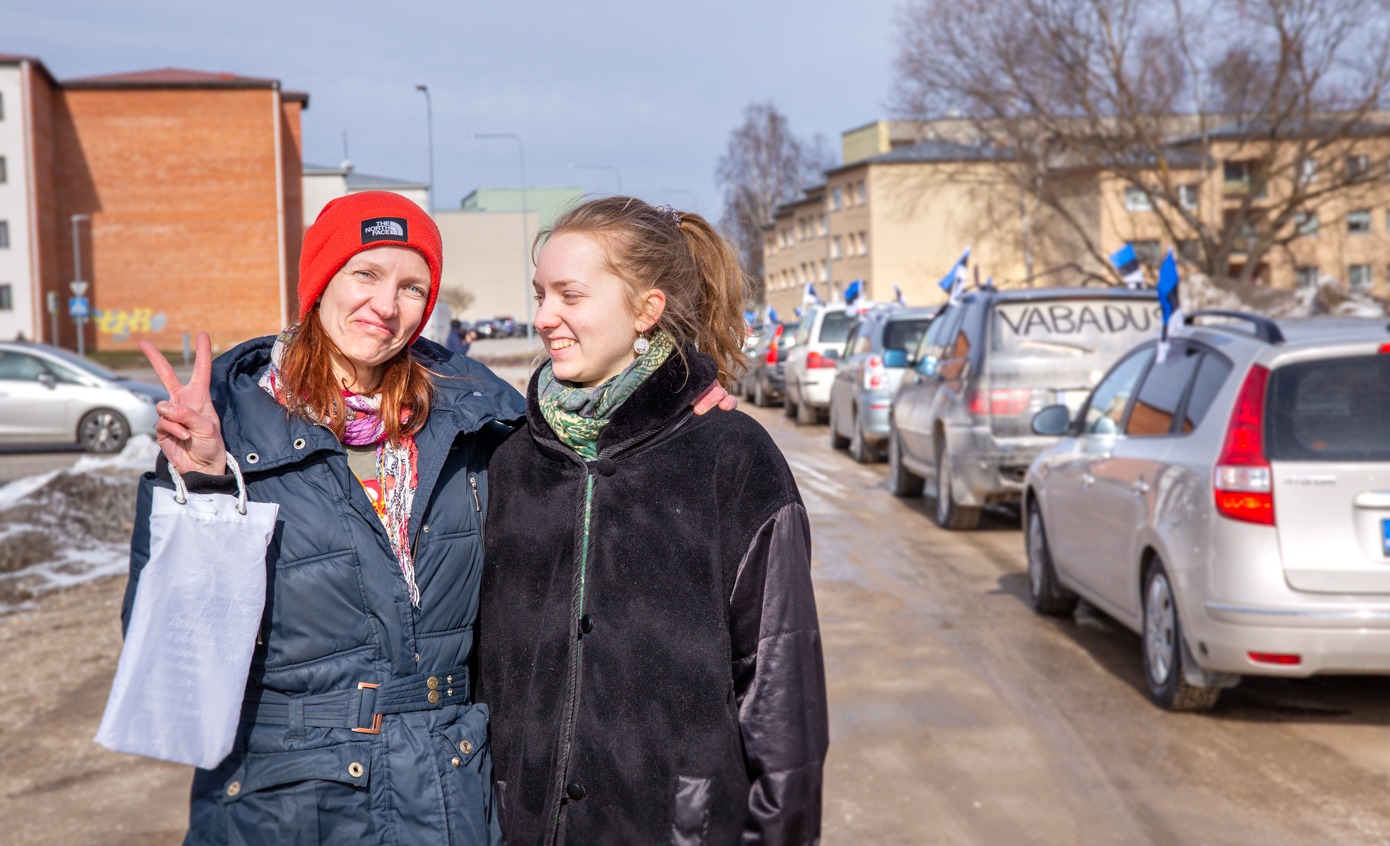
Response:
[[888, 288, 1162, 529]]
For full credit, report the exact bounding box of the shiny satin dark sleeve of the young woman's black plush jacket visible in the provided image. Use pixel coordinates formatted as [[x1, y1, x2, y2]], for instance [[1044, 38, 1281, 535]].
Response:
[[728, 501, 830, 845]]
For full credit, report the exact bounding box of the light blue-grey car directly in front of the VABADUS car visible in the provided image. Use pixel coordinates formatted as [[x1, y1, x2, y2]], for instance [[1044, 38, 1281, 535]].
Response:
[[830, 307, 938, 464]]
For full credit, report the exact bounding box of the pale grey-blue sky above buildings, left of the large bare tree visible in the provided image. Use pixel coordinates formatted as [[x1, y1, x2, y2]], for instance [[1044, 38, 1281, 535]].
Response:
[[8, 0, 899, 215]]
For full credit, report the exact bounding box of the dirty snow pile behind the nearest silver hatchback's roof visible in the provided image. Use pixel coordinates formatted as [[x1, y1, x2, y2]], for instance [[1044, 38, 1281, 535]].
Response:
[[1179, 274, 1390, 318]]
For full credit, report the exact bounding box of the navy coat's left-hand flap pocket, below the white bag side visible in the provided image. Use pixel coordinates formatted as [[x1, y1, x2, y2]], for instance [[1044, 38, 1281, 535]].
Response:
[[210, 742, 375, 846]]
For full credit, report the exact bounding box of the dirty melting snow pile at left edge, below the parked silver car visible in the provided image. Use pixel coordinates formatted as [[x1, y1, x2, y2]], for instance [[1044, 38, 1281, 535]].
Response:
[[0, 435, 160, 613]]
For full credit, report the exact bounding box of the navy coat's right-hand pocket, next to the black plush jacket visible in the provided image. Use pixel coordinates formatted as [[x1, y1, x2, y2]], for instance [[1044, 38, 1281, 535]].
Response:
[[435, 704, 502, 845]]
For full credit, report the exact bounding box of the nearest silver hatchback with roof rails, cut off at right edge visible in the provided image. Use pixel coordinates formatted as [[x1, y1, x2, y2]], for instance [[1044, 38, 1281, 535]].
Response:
[[1023, 311, 1390, 710]]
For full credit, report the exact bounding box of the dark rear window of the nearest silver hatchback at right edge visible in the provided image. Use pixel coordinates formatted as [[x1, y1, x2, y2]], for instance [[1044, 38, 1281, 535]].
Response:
[[1265, 356, 1390, 461]]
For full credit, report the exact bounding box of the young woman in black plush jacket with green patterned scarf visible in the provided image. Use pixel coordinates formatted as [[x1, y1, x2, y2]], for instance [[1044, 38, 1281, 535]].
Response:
[[478, 197, 828, 846]]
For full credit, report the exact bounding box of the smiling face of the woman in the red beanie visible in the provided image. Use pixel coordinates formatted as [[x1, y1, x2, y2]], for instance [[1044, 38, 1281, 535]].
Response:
[[318, 246, 430, 371]]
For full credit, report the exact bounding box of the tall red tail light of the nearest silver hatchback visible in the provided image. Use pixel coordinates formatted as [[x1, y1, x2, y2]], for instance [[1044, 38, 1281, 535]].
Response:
[[1212, 364, 1275, 526]]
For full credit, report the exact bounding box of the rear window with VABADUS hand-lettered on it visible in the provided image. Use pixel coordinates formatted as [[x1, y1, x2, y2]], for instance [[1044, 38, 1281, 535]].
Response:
[[990, 297, 1162, 360]]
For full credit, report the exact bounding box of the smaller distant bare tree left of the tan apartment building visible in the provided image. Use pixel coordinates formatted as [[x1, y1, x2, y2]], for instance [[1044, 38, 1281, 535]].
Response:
[[714, 101, 835, 300]]
